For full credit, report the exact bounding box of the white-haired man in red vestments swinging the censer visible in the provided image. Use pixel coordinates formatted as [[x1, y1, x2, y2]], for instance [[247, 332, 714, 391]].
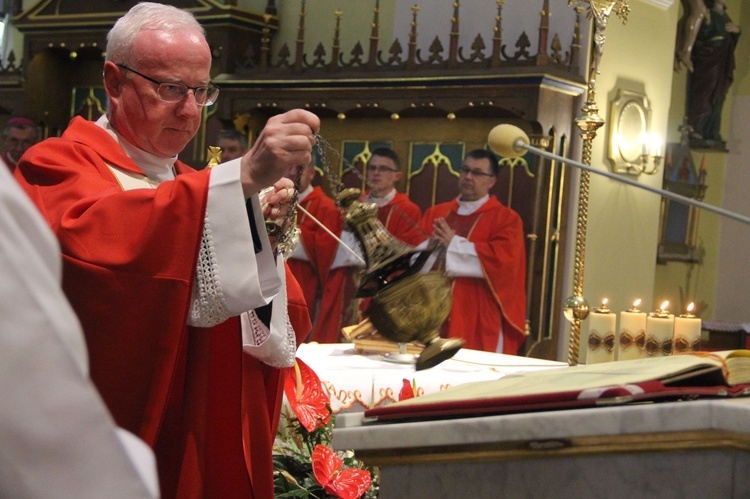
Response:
[[16, 3, 320, 498]]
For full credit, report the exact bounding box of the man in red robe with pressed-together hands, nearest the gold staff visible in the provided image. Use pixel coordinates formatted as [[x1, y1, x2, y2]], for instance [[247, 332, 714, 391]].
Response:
[[422, 149, 526, 355]]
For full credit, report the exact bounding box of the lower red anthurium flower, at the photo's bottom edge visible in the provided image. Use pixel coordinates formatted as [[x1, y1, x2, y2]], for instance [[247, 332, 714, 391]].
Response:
[[312, 445, 372, 499]]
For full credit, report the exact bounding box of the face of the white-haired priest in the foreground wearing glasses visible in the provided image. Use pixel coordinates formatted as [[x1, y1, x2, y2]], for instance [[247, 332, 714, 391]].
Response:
[[104, 26, 211, 158]]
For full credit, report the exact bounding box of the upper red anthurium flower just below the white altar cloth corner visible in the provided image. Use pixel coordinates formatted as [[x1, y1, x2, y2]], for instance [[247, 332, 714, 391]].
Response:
[[284, 359, 331, 432]]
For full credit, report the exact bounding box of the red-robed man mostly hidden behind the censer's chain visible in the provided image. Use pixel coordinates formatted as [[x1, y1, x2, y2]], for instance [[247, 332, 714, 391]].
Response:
[[287, 163, 342, 334]]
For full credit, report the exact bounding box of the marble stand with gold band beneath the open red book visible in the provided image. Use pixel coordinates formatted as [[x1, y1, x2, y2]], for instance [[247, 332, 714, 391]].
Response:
[[333, 398, 750, 499]]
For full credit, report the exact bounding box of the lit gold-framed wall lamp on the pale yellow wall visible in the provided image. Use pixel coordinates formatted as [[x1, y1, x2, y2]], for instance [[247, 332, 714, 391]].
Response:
[[607, 89, 663, 175]]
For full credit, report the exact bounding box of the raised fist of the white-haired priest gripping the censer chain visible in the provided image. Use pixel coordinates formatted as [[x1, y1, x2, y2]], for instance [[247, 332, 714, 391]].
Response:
[[240, 109, 320, 199]]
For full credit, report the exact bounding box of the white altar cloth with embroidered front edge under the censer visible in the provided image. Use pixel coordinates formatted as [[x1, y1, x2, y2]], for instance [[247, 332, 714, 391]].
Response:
[[297, 343, 567, 414]]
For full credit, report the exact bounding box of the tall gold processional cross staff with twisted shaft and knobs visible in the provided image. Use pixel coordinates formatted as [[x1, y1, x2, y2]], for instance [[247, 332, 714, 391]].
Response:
[[563, 0, 630, 366]]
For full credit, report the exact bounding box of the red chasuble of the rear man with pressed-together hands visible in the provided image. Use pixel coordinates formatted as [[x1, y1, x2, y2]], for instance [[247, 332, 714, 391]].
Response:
[[422, 196, 526, 355]]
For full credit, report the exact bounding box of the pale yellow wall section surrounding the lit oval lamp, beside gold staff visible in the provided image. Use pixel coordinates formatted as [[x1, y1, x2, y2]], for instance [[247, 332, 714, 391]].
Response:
[[571, 0, 678, 331]]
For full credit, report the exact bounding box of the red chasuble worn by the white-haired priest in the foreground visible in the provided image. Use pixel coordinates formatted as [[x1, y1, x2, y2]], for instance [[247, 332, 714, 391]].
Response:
[[16, 118, 304, 498]]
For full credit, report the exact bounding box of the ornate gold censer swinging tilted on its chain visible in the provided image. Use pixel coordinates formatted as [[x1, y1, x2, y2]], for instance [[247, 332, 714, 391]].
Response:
[[338, 189, 464, 371]]
